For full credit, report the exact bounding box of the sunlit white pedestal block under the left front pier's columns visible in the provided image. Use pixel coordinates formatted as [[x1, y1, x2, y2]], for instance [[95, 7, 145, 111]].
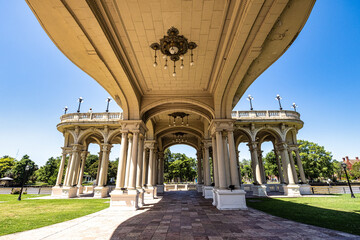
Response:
[[109, 190, 139, 210]]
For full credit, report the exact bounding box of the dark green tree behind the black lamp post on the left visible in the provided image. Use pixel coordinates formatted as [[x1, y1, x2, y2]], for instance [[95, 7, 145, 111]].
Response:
[[12, 155, 38, 183]]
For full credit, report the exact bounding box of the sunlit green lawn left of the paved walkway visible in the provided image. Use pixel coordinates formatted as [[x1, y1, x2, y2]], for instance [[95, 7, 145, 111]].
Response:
[[0, 194, 109, 236]]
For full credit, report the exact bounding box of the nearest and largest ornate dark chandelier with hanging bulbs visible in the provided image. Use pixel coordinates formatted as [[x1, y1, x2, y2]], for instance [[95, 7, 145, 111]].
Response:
[[150, 27, 197, 77]]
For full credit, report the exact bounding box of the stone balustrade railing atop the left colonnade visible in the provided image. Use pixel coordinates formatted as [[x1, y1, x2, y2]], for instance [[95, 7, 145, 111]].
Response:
[[60, 112, 123, 123]]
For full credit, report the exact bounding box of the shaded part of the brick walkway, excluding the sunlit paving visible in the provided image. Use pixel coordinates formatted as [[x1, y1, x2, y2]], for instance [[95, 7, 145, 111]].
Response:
[[111, 191, 360, 240]]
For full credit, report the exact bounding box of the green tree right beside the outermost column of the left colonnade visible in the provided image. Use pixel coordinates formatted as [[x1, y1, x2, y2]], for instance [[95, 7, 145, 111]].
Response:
[[35, 157, 61, 185]]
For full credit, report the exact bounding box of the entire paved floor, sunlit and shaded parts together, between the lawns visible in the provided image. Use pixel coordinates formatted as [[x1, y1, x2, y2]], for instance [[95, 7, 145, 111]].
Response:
[[0, 191, 360, 240]]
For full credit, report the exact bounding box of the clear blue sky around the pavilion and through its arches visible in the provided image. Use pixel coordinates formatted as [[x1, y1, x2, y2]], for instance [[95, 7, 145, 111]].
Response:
[[0, 0, 360, 166]]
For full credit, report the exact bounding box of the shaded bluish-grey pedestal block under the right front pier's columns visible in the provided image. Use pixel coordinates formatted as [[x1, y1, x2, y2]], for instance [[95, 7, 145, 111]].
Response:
[[215, 189, 247, 210]]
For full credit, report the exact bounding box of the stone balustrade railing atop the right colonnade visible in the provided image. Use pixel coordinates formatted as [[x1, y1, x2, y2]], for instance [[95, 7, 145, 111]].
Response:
[[231, 110, 300, 120]]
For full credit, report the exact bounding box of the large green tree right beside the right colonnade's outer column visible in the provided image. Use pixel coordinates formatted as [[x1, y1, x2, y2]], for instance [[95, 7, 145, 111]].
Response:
[[298, 140, 335, 180]]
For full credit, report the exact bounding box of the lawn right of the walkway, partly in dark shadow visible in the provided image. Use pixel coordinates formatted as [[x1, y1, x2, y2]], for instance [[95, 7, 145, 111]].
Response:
[[247, 194, 360, 235]]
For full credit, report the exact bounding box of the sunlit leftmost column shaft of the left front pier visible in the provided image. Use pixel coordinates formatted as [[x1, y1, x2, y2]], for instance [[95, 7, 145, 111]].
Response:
[[115, 131, 128, 190]]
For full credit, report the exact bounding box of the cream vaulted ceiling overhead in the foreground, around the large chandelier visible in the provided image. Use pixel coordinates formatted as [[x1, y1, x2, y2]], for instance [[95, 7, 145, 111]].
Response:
[[26, 0, 315, 119]]
